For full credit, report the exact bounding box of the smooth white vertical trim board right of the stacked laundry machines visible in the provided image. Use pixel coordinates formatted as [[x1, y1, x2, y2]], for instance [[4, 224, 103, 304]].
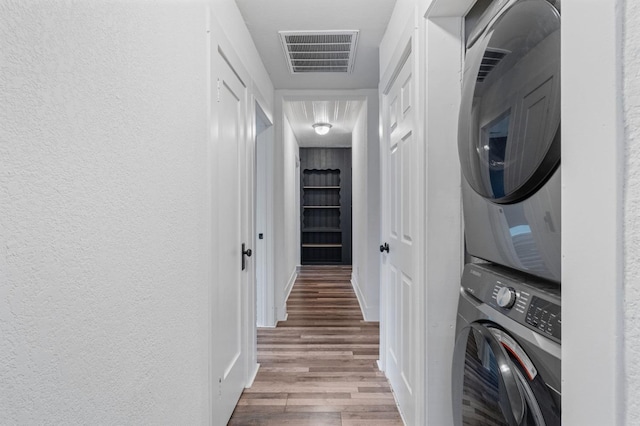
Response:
[[561, 0, 624, 425]]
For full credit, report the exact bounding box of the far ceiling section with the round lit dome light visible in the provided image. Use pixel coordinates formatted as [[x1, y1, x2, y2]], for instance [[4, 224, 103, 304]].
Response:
[[284, 100, 364, 148]]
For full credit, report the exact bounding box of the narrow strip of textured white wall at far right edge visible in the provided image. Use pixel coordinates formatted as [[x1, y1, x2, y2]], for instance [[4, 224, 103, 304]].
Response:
[[623, 1, 640, 425]]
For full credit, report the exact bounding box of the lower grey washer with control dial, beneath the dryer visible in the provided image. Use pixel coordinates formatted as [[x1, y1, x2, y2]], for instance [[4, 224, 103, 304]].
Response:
[[451, 264, 562, 426]]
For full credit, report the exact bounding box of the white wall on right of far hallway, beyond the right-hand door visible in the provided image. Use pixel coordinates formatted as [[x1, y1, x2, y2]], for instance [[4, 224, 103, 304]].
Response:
[[351, 90, 380, 321]]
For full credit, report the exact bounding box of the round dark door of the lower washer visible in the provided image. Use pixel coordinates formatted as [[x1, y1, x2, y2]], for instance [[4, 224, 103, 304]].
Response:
[[452, 323, 560, 426]]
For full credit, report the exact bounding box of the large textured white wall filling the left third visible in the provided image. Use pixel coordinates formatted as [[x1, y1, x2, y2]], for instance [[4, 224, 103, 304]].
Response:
[[0, 0, 209, 424]]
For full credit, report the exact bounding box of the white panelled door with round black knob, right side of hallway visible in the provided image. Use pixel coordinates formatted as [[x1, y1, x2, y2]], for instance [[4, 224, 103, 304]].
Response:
[[380, 28, 424, 424]]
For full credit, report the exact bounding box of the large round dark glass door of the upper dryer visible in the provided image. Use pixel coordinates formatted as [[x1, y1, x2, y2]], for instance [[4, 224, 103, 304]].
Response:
[[458, 0, 560, 204]]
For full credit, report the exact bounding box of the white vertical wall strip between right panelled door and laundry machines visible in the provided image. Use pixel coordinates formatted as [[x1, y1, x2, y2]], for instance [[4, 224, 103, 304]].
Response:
[[425, 16, 463, 425]]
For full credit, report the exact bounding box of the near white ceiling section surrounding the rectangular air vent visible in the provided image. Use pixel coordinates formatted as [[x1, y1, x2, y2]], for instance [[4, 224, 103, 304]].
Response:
[[236, 0, 396, 89]]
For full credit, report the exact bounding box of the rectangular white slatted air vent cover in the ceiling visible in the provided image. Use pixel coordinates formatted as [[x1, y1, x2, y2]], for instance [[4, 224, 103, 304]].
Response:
[[279, 30, 358, 74]]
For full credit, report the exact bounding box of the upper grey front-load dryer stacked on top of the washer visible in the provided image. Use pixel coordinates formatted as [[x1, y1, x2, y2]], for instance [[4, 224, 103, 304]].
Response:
[[458, 0, 561, 283]]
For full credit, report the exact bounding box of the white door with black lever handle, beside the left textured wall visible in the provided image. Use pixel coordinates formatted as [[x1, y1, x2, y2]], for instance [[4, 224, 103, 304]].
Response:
[[207, 15, 258, 426]]
